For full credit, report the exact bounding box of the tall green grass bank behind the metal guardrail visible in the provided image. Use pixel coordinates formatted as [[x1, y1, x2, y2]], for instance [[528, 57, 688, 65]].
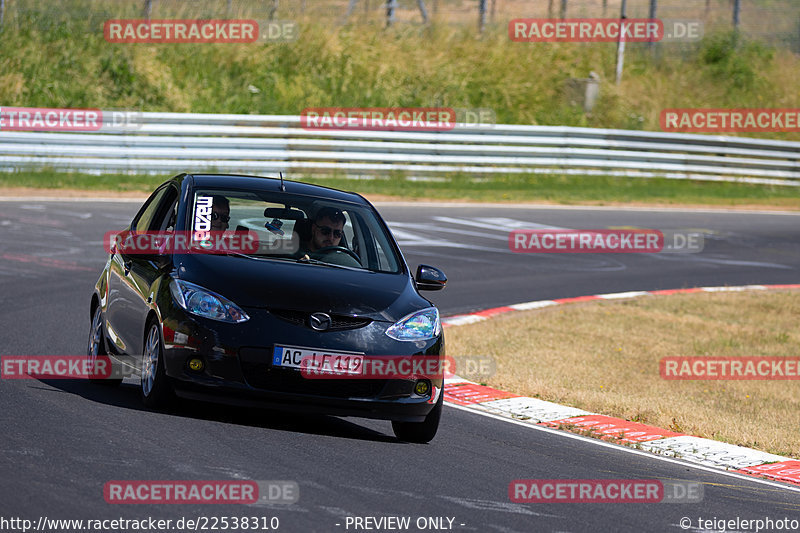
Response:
[[0, 12, 800, 140]]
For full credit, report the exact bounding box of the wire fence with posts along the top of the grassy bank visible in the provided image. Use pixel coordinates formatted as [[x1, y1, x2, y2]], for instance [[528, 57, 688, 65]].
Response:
[[0, 0, 800, 53]]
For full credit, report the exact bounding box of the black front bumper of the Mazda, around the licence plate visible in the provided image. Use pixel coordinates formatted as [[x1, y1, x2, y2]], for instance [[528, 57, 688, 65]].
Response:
[[156, 307, 444, 422]]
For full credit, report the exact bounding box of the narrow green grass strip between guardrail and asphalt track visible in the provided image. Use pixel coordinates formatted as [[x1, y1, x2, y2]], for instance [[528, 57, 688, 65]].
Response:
[[6, 171, 800, 209]]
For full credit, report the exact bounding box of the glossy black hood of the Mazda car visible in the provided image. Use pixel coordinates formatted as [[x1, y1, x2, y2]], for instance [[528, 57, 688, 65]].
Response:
[[176, 254, 431, 322]]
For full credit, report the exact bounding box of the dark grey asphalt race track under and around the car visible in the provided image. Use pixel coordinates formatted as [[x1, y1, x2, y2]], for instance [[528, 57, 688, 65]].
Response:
[[0, 201, 800, 533]]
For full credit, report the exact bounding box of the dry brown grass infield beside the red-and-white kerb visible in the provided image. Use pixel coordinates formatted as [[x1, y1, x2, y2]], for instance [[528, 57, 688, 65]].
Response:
[[447, 291, 800, 457]]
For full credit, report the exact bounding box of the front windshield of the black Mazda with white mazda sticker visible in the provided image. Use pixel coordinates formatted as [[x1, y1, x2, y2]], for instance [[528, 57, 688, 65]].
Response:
[[190, 188, 401, 273]]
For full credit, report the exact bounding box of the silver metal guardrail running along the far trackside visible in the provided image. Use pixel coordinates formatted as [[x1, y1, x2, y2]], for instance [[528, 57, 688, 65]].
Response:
[[0, 113, 800, 186]]
